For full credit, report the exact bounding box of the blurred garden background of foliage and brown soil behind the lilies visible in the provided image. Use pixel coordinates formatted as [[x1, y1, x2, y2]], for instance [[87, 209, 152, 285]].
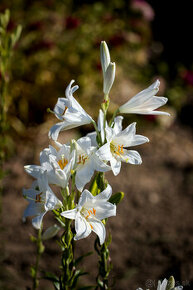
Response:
[[0, 0, 193, 290]]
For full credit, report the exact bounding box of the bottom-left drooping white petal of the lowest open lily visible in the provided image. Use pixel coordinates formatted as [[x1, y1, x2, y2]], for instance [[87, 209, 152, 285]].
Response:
[[74, 213, 91, 240]]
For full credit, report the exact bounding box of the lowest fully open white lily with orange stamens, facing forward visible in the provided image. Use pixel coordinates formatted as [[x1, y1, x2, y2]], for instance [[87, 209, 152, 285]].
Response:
[[61, 185, 116, 245]]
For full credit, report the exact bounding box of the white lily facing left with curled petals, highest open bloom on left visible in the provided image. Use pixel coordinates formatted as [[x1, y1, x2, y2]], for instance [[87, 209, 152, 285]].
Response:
[[49, 80, 93, 140]]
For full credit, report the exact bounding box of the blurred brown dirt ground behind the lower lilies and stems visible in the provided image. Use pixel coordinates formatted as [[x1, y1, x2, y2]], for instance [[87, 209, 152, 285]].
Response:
[[0, 119, 193, 290]]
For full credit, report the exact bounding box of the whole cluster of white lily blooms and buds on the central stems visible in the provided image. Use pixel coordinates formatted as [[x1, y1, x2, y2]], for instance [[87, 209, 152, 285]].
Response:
[[23, 42, 169, 244]]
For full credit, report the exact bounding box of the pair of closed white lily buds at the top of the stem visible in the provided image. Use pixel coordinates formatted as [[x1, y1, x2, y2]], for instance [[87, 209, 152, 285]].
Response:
[[100, 41, 115, 95]]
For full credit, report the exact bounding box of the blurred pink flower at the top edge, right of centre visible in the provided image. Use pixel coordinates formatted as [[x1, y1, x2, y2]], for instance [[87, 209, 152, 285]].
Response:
[[131, 0, 155, 21]]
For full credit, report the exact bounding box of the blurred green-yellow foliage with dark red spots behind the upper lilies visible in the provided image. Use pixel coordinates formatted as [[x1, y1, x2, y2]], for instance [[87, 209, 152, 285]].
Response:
[[0, 0, 192, 134]]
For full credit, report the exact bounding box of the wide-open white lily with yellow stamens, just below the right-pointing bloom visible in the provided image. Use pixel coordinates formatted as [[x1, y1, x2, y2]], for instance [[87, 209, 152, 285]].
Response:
[[96, 116, 149, 175]]
